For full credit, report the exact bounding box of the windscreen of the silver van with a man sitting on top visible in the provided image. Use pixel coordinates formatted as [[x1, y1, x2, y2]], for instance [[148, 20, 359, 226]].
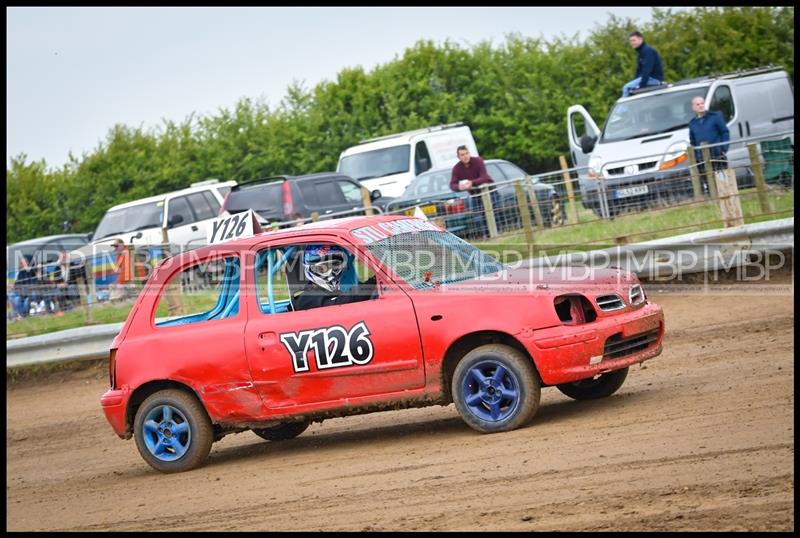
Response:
[[601, 86, 709, 142]]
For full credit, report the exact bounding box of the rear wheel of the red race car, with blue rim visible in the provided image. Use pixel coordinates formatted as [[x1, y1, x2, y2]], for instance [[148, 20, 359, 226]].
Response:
[[133, 389, 214, 473]]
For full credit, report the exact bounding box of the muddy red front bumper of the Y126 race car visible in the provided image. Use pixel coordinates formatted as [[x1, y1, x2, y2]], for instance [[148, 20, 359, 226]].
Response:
[[523, 303, 664, 385]]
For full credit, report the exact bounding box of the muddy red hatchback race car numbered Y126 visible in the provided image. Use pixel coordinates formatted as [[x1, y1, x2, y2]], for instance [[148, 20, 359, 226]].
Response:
[[101, 216, 664, 472]]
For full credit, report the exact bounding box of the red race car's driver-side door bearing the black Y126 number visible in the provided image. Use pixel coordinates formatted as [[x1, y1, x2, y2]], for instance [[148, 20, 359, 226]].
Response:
[[244, 236, 425, 414]]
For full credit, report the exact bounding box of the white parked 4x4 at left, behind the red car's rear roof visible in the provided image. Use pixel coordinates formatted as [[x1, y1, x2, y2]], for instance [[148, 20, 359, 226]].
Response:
[[91, 179, 236, 250]]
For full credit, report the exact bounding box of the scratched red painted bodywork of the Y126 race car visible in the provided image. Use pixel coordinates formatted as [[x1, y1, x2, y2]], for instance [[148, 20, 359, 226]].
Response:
[[101, 216, 664, 437]]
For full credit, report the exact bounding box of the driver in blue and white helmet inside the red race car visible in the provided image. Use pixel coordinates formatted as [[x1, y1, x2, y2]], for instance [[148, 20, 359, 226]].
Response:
[[292, 245, 378, 310]]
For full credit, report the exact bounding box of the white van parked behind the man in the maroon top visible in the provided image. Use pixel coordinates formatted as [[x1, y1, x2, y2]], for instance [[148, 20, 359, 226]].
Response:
[[336, 123, 478, 197]]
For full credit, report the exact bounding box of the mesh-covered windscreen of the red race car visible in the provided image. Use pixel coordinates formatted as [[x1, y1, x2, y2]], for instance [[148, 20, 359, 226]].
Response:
[[367, 231, 503, 289]]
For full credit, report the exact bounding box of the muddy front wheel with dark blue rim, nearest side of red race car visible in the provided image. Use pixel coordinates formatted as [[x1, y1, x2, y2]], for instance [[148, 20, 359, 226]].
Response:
[[452, 344, 541, 433]]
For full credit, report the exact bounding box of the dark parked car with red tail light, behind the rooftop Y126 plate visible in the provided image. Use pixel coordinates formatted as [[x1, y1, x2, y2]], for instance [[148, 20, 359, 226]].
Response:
[[219, 172, 382, 224]]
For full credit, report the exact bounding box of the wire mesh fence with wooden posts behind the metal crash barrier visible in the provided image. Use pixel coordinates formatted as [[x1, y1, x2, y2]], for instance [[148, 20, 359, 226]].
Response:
[[7, 131, 794, 323]]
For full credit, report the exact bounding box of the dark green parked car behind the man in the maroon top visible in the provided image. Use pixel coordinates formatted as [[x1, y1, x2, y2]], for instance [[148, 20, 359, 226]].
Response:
[[387, 159, 565, 236]]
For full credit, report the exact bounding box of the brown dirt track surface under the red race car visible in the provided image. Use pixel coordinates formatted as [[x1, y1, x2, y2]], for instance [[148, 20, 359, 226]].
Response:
[[6, 280, 794, 531]]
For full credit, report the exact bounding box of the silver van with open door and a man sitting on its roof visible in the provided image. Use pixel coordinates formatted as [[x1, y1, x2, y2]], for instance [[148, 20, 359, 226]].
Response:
[[567, 67, 794, 214]]
